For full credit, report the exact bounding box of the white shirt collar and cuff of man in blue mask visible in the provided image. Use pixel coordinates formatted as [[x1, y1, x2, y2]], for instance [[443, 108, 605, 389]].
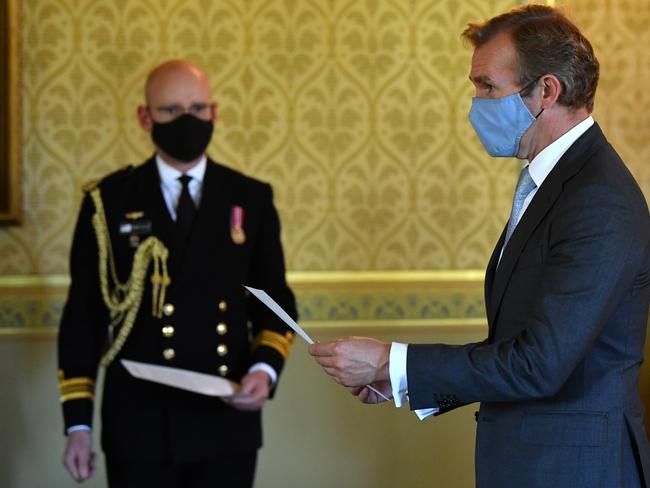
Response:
[[388, 116, 594, 420]]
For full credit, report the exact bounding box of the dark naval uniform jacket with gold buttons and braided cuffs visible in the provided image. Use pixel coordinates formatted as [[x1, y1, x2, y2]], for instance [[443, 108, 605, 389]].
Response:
[[59, 158, 296, 462]]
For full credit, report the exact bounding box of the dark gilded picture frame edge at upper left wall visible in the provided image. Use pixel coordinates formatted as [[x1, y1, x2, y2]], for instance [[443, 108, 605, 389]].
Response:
[[0, 0, 22, 225]]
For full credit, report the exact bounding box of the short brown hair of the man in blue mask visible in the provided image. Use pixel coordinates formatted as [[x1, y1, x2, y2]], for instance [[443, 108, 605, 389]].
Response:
[[462, 4, 600, 112]]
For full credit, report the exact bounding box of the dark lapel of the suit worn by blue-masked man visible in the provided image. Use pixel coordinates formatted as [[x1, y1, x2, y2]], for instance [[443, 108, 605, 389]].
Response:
[[485, 123, 605, 332]]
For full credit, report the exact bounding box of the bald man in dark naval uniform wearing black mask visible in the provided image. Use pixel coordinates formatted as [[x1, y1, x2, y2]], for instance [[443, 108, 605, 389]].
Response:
[[59, 60, 296, 488]]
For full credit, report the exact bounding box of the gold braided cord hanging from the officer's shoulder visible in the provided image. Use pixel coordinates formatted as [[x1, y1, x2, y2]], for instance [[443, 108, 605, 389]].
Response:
[[90, 188, 171, 367]]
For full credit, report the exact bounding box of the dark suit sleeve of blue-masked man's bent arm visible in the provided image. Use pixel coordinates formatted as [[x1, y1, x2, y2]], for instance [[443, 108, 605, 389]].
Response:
[[407, 184, 647, 413]]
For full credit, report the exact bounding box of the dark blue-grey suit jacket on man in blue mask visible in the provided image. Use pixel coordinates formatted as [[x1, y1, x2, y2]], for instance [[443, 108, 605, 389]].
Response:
[[407, 124, 650, 488]]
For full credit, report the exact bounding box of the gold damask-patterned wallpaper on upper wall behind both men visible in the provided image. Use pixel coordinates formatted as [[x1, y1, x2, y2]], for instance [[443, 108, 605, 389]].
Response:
[[0, 0, 650, 275]]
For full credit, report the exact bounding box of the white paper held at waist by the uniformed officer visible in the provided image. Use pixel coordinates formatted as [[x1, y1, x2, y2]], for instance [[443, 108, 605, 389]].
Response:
[[120, 359, 239, 397]]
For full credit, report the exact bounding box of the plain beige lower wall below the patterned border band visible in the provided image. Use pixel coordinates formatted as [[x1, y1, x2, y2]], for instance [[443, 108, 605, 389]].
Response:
[[0, 326, 484, 488]]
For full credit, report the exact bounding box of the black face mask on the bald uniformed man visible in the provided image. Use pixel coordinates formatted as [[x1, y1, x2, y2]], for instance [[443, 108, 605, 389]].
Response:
[[151, 114, 214, 163]]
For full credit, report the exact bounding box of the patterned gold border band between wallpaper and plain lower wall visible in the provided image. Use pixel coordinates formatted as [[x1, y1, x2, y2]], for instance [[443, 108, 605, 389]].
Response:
[[0, 270, 485, 337]]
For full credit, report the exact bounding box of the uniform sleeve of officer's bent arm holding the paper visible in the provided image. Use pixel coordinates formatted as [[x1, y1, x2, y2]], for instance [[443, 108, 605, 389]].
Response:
[[249, 185, 298, 375]]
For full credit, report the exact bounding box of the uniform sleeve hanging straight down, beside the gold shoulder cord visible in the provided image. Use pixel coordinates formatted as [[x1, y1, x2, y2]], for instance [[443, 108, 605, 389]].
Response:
[[58, 195, 108, 429]]
